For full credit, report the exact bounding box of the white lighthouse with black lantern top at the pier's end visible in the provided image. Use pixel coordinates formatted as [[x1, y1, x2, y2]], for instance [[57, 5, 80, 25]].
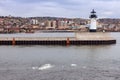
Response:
[[89, 9, 97, 32]]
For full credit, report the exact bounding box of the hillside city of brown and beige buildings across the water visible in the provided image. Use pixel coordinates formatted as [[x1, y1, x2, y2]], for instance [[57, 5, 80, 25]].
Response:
[[0, 16, 120, 33]]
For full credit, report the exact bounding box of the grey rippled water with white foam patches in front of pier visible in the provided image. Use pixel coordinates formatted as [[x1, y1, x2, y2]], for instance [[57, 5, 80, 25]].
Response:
[[0, 33, 120, 80]]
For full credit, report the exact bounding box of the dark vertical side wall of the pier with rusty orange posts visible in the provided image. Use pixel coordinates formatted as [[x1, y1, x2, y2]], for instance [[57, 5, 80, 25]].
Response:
[[0, 38, 116, 45]]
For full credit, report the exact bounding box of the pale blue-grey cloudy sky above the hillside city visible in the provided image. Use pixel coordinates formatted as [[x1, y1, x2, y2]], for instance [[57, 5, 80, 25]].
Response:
[[0, 0, 120, 18]]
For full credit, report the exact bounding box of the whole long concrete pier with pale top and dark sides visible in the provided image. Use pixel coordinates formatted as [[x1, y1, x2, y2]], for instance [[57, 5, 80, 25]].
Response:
[[0, 32, 116, 45]]
